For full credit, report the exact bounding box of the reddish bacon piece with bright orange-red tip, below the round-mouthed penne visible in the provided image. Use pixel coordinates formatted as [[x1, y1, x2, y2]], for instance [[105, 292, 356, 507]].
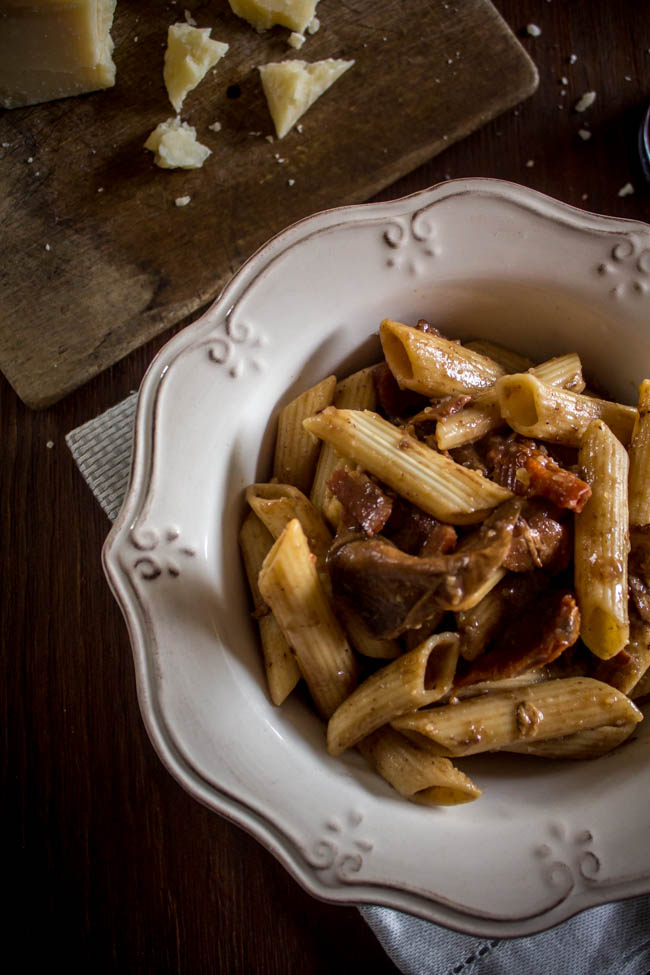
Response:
[[486, 435, 591, 513]]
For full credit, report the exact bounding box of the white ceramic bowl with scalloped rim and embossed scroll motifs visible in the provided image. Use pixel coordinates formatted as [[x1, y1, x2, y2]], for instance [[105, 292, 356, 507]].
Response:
[[104, 179, 650, 936]]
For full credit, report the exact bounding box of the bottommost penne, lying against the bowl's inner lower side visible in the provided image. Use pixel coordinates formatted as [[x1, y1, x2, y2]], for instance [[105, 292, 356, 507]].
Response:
[[357, 728, 481, 806]]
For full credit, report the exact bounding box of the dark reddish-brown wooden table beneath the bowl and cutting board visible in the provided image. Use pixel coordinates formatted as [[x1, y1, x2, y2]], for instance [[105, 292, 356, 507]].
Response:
[[5, 0, 650, 975]]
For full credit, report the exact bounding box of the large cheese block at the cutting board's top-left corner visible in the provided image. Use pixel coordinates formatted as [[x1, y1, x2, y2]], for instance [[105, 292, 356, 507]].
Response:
[[0, 0, 115, 108]]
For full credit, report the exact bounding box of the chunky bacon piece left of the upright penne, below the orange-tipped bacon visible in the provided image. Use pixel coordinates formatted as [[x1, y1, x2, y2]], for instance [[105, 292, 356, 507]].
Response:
[[503, 498, 573, 573]]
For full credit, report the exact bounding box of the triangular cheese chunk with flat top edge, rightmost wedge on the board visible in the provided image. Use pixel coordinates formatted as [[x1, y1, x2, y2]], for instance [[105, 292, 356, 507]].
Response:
[[258, 58, 354, 139]]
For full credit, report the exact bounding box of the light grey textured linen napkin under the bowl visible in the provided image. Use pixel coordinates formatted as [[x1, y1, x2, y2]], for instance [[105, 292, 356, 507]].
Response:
[[66, 393, 650, 975]]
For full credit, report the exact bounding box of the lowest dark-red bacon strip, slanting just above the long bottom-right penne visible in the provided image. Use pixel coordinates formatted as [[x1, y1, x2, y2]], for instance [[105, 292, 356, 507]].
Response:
[[454, 591, 580, 690]]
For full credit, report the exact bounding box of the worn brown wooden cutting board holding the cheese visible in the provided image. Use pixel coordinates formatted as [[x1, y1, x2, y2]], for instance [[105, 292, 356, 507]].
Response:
[[0, 0, 537, 407]]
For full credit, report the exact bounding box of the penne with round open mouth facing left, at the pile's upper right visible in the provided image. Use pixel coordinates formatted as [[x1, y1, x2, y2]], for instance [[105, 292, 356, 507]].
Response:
[[496, 372, 638, 447]]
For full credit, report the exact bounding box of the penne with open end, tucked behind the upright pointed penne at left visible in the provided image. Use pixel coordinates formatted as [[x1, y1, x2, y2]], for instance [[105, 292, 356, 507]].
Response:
[[246, 484, 332, 571]]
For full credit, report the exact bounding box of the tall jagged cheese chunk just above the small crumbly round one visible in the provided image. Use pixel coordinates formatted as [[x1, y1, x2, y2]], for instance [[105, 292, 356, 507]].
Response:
[[163, 24, 228, 112]]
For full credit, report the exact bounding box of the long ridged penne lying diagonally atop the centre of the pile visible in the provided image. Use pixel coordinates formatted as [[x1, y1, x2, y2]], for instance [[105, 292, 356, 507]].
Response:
[[304, 407, 512, 525]]
